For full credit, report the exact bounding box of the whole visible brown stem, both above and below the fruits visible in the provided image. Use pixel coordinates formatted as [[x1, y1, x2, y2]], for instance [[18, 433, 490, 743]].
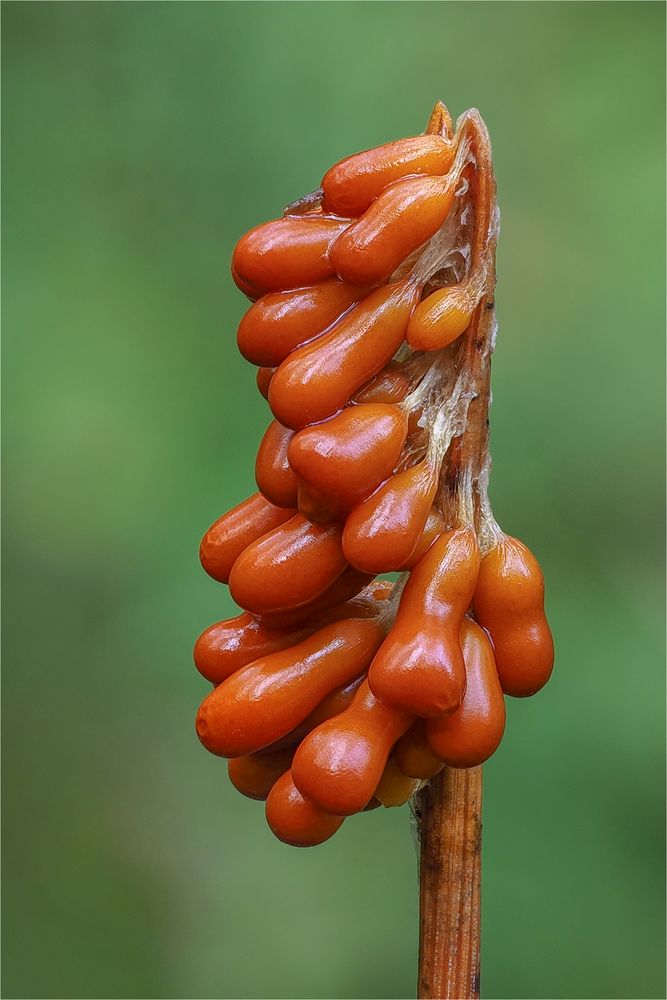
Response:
[[416, 105, 496, 1000]]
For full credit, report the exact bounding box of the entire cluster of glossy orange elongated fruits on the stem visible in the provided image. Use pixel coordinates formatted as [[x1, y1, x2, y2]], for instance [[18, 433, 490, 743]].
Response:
[[194, 104, 553, 846]]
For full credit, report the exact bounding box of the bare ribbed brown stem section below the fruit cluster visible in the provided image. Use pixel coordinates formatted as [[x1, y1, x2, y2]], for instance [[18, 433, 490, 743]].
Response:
[[418, 767, 482, 1000]]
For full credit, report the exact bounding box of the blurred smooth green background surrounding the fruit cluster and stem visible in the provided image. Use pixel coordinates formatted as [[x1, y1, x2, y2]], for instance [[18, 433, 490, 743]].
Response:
[[2, 2, 665, 998]]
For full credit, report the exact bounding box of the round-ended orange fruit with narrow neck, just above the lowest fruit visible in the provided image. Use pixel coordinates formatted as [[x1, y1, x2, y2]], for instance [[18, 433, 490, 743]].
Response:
[[292, 681, 414, 816]]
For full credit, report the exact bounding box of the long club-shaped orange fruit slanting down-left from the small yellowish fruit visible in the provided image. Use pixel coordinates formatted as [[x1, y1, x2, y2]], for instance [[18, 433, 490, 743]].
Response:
[[269, 281, 419, 430]]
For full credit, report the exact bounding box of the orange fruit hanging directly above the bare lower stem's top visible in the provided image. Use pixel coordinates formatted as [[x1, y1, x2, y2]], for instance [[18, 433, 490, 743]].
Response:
[[426, 618, 505, 767]]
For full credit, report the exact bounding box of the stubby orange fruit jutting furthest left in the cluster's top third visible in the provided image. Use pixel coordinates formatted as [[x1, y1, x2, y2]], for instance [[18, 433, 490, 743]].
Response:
[[232, 216, 347, 292]]
